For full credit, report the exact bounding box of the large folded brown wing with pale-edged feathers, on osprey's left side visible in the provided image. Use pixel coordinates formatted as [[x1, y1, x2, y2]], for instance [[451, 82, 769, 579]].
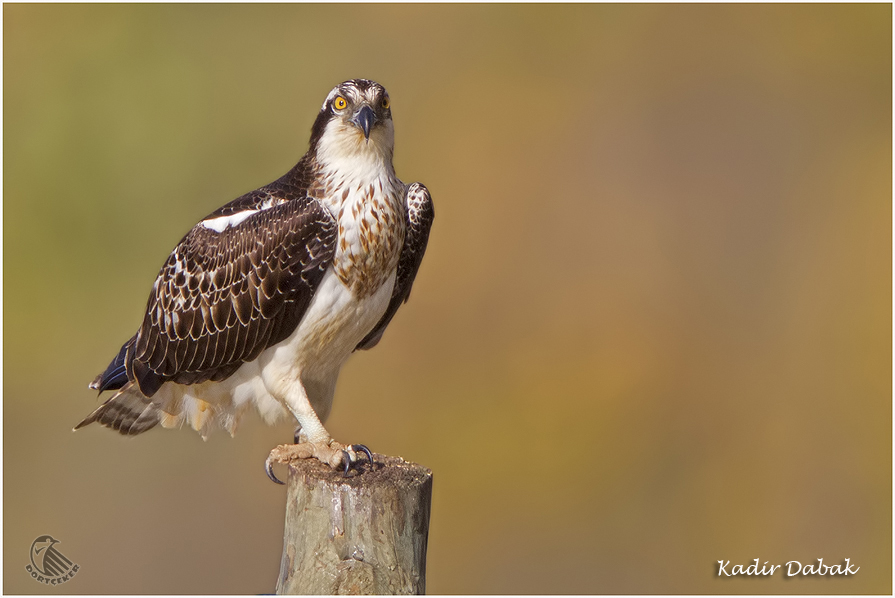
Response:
[[130, 196, 337, 397]]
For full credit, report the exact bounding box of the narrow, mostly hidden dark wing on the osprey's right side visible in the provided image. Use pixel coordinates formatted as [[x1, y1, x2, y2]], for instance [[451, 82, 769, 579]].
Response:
[[354, 183, 435, 351]]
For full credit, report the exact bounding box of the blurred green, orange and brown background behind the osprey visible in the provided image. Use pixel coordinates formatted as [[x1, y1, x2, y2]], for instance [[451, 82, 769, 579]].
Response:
[[3, 4, 892, 594]]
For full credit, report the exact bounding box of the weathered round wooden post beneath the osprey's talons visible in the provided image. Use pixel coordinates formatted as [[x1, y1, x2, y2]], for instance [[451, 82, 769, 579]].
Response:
[[277, 455, 432, 595]]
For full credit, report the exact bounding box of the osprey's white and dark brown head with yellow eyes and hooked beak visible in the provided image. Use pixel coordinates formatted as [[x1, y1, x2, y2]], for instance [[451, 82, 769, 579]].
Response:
[[311, 79, 395, 171]]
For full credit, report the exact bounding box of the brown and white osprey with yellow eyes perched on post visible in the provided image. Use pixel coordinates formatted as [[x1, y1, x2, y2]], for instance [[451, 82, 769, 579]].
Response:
[[75, 79, 435, 483]]
